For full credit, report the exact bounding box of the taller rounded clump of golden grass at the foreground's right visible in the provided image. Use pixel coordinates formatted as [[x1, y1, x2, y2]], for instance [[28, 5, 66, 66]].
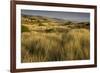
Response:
[[63, 29, 90, 60]]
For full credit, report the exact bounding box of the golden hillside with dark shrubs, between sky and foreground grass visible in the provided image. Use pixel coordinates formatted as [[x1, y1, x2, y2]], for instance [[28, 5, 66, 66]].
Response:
[[21, 15, 90, 32]]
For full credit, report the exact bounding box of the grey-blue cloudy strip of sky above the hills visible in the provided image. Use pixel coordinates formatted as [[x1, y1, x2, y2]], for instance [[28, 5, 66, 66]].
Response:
[[21, 9, 90, 22]]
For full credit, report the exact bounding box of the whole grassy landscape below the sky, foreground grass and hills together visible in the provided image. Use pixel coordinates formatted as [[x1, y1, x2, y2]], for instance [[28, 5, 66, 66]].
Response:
[[21, 15, 90, 63]]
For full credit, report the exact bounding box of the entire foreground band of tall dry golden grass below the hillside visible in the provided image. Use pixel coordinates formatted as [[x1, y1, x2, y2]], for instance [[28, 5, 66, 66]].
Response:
[[22, 29, 90, 62]]
